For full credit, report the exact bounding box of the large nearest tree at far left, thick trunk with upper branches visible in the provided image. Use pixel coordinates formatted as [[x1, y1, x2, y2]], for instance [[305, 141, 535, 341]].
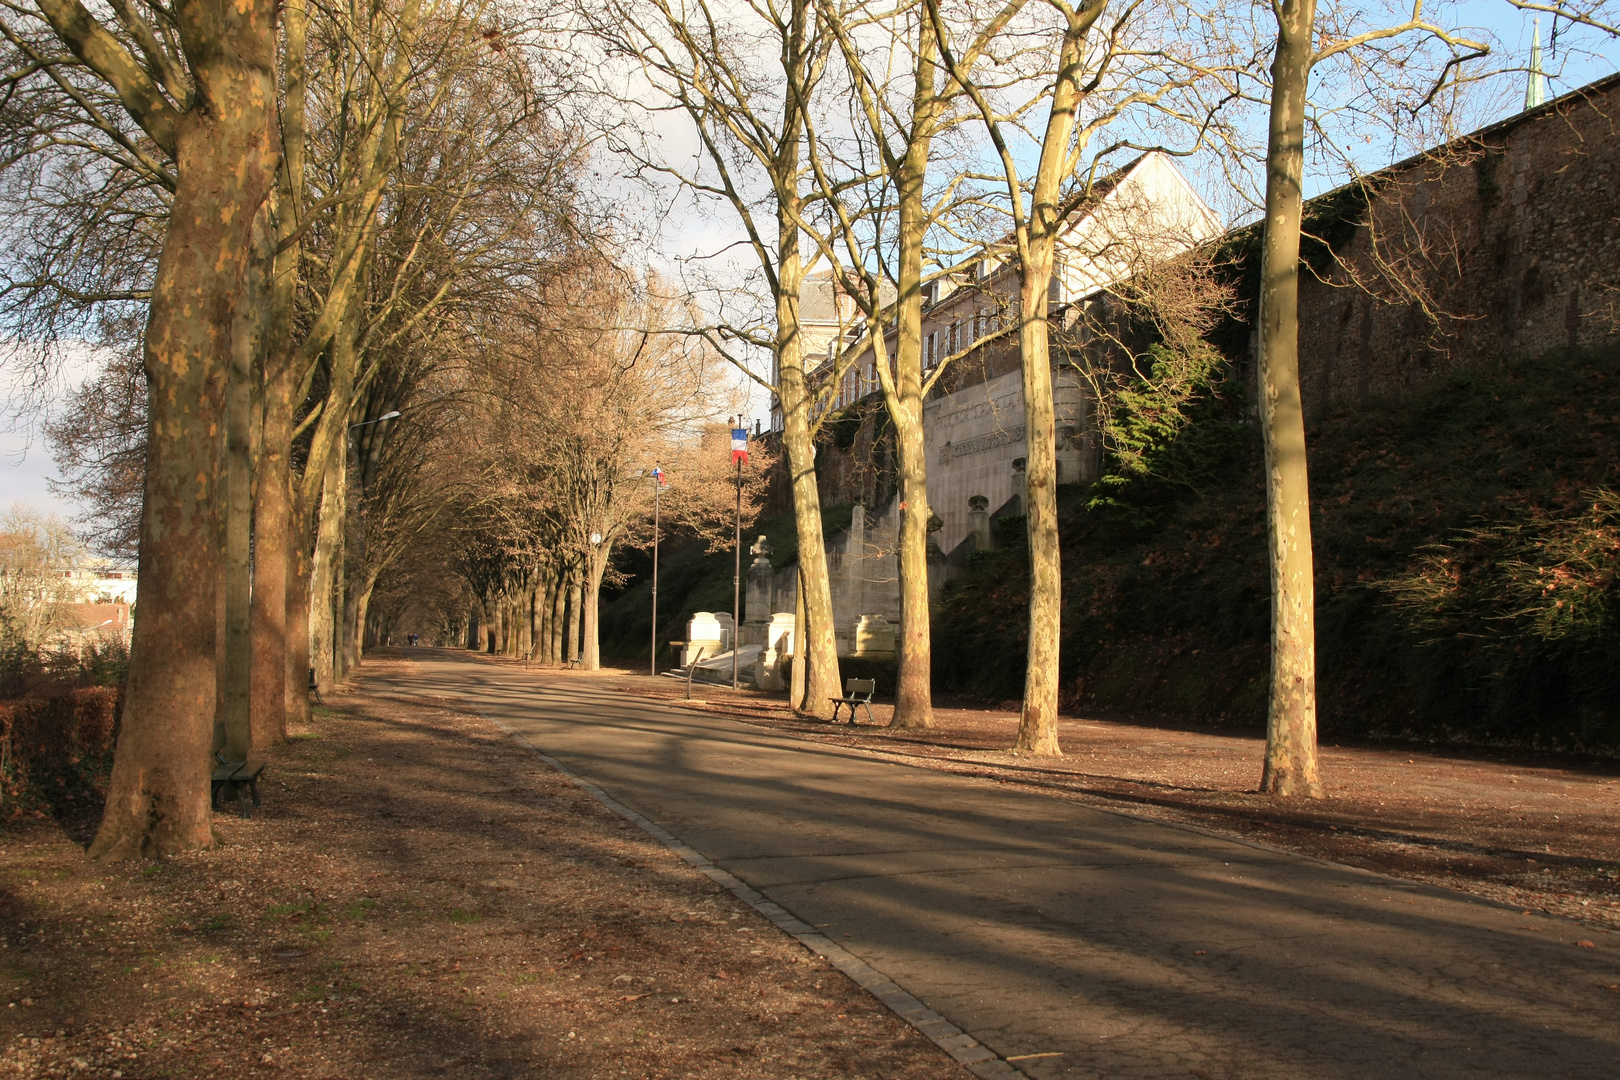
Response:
[[0, 0, 279, 858]]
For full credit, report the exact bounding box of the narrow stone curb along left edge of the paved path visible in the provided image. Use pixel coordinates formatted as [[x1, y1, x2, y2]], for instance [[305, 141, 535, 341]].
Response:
[[480, 711, 1029, 1080]]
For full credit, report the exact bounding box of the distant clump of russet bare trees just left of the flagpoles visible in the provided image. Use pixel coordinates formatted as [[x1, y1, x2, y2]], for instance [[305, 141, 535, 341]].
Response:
[[441, 259, 771, 670]]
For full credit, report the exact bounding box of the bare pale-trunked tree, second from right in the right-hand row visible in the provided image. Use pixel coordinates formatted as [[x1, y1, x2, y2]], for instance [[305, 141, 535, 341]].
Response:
[[927, 0, 1230, 755]]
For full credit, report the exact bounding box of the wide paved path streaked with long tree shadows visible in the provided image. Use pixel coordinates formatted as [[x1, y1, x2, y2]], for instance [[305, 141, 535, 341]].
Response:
[[371, 649, 1620, 1080]]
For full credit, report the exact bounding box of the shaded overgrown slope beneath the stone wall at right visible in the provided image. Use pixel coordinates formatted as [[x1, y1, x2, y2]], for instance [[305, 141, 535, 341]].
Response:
[[935, 350, 1620, 751]]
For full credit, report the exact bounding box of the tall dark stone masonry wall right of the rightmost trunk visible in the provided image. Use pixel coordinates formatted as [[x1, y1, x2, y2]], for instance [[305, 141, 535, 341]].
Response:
[[1299, 76, 1620, 415]]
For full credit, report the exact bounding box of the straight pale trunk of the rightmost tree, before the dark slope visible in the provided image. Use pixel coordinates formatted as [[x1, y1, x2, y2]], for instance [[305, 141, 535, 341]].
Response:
[[1260, 0, 1322, 798]]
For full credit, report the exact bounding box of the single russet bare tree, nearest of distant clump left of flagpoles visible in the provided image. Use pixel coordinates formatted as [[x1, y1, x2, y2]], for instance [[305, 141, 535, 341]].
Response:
[[463, 266, 751, 670]]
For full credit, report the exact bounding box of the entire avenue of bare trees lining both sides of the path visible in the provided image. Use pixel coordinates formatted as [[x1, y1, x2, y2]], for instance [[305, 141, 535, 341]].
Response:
[[0, 0, 1612, 857]]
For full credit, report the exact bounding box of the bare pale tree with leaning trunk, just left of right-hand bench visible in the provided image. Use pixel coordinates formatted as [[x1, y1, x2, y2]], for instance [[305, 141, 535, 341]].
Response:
[[586, 0, 839, 717]]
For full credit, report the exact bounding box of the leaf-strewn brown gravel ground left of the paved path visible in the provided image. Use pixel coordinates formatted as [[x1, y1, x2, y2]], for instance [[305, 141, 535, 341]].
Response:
[[0, 656, 967, 1080]]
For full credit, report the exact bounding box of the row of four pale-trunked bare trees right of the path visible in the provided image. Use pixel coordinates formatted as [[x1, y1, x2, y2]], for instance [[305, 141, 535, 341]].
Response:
[[577, 0, 1612, 795]]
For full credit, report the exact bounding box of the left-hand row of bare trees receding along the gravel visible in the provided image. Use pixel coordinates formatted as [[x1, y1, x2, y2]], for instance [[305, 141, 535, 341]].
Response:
[[0, 0, 612, 858]]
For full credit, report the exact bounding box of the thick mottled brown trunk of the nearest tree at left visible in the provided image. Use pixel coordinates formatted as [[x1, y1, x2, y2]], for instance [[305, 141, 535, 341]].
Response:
[[85, 14, 277, 858]]
